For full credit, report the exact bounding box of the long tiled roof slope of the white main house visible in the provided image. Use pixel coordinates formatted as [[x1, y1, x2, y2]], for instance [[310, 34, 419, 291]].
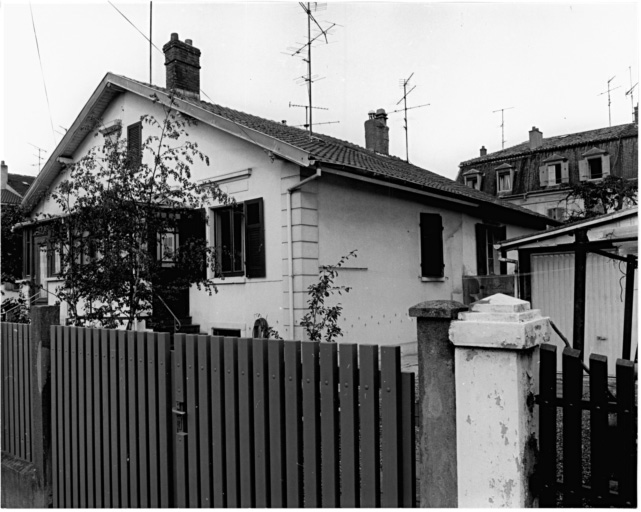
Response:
[[132, 77, 555, 224]]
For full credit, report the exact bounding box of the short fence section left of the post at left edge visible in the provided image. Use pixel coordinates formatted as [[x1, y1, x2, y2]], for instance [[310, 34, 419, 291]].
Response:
[[0, 322, 33, 462]]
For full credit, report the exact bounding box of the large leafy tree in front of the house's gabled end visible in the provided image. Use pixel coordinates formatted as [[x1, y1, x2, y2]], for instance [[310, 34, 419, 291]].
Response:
[[41, 95, 229, 329]]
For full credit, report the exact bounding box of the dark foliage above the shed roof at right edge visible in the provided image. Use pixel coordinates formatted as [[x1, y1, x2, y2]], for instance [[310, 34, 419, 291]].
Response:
[[566, 175, 638, 221]]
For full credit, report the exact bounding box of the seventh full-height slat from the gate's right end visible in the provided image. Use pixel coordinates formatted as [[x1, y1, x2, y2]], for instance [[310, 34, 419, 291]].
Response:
[[267, 340, 286, 508]]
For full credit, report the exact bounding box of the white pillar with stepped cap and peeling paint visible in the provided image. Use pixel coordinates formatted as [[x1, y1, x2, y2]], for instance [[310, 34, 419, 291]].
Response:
[[450, 294, 550, 508]]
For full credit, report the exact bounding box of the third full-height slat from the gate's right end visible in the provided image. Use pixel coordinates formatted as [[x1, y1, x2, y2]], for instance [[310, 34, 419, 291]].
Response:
[[338, 343, 360, 508]]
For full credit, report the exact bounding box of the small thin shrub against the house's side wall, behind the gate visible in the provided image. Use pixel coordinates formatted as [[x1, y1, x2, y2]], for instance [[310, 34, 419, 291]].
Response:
[[300, 250, 357, 343]]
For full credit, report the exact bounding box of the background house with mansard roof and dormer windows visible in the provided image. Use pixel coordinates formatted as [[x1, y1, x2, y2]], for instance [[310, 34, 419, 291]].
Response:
[[457, 123, 639, 220]]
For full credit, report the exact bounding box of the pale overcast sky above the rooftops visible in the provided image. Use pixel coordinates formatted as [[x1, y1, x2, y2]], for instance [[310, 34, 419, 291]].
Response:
[[0, 0, 639, 182]]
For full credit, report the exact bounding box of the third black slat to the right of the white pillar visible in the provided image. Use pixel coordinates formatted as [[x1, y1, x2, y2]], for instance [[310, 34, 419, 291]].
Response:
[[590, 354, 610, 506]]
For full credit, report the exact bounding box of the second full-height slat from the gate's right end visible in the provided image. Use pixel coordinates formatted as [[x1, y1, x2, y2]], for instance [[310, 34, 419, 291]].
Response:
[[359, 345, 381, 508]]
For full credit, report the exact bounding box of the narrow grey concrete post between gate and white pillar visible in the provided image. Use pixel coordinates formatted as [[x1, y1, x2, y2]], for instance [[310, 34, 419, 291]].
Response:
[[409, 300, 467, 508]]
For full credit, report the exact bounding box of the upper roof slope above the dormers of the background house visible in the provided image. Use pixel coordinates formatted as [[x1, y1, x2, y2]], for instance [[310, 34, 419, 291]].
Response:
[[460, 123, 639, 167]]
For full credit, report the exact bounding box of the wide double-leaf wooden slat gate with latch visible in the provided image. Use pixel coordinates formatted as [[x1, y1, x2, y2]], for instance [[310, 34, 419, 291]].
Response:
[[46, 326, 416, 508]]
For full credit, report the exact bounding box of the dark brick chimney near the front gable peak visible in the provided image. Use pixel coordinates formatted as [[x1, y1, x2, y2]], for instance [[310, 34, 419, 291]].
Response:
[[162, 33, 200, 99]]
